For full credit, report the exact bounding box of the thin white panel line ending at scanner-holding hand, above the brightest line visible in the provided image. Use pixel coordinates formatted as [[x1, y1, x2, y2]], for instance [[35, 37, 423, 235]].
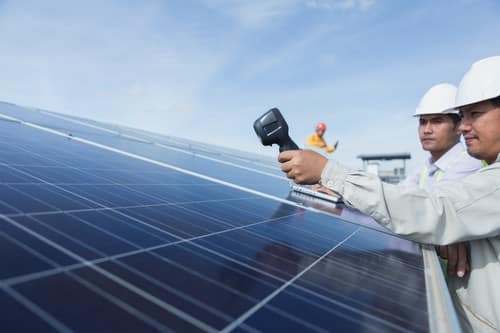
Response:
[[37, 112, 287, 180]]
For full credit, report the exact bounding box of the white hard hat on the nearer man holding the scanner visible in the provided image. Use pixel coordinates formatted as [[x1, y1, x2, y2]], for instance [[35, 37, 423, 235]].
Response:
[[454, 56, 500, 108]]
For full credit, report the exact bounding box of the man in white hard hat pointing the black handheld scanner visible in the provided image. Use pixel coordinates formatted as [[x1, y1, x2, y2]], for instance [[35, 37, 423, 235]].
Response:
[[278, 56, 500, 332]]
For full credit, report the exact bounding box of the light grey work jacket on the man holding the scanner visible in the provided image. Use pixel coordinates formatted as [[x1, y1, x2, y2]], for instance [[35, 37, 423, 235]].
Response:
[[321, 154, 500, 332]]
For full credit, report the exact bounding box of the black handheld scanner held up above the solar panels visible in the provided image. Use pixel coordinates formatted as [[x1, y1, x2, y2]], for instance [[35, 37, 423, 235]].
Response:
[[253, 108, 299, 153]]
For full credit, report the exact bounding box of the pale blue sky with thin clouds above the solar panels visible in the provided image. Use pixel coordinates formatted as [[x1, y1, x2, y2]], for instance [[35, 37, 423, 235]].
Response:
[[0, 0, 500, 167]]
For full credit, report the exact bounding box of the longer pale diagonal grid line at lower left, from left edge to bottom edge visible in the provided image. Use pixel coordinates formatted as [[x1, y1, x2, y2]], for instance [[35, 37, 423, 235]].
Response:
[[0, 215, 217, 332]]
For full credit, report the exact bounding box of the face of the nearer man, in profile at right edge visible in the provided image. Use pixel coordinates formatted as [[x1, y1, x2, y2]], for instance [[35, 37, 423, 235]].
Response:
[[459, 101, 500, 164]]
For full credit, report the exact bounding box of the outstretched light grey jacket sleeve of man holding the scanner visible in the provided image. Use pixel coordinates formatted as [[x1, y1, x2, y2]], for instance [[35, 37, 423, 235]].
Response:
[[321, 161, 500, 245]]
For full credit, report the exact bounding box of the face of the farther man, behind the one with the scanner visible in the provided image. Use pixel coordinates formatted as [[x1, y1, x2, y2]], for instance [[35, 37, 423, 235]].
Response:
[[418, 114, 460, 157]]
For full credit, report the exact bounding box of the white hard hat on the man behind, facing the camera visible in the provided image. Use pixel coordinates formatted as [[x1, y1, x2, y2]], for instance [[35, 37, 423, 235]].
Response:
[[415, 83, 458, 116]]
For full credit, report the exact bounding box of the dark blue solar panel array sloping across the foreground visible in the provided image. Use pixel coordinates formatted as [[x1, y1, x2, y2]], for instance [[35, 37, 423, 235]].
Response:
[[0, 105, 429, 332]]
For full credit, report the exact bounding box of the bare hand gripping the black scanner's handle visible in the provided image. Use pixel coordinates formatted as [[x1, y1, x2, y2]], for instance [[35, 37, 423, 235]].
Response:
[[278, 150, 328, 185]]
